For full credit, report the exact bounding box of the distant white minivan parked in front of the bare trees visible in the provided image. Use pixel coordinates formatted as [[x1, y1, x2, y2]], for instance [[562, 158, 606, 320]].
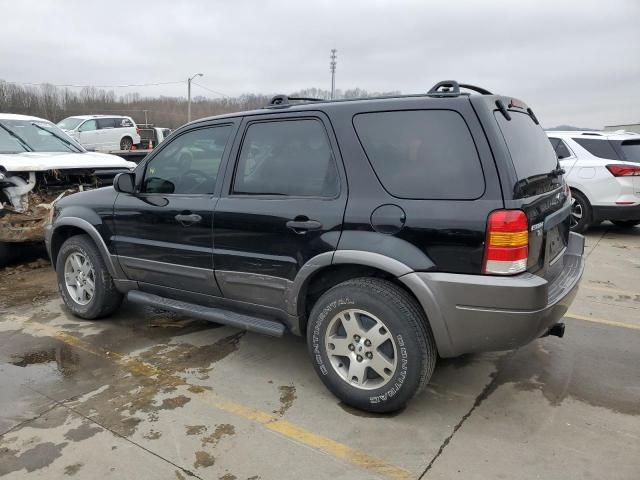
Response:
[[58, 115, 140, 152]]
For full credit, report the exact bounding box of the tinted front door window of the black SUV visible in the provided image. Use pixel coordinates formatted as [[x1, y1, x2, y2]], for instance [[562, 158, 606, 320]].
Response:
[[142, 126, 231, 194]]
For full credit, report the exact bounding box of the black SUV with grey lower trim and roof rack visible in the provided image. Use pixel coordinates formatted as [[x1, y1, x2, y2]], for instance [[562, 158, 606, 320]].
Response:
[[47, 81, 584, 412]]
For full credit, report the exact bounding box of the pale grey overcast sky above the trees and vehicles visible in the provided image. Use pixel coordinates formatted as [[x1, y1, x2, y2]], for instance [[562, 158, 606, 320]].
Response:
[[0, 0, 640, 128]]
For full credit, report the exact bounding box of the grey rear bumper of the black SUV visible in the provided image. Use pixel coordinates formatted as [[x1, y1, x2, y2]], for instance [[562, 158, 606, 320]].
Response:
[[400, 232, 584, 357]]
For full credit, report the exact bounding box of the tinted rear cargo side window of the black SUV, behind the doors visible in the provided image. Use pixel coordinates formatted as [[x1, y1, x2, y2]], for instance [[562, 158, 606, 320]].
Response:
[[353, 110, 482, 200]]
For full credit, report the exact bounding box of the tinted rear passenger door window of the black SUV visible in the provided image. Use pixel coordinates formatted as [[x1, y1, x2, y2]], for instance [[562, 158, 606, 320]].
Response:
[[233, 120, 338, 197]]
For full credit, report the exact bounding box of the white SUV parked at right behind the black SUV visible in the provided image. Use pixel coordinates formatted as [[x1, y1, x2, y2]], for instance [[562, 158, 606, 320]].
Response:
[[547, 130, 640, 232]]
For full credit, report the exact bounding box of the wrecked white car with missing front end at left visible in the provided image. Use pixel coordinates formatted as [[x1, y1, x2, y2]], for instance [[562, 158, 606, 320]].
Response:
[[0, 113, 135, 266]]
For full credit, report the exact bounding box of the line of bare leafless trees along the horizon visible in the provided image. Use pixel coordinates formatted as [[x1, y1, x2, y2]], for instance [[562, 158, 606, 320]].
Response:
[[0, 80, 400, 128]]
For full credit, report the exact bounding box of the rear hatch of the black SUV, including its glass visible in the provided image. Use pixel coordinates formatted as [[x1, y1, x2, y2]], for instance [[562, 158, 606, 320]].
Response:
[[494, 99, 570, 281]]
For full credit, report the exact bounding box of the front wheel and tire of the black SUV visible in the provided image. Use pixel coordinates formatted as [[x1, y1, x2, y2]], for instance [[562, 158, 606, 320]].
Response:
[[56, 235, 122, 320]]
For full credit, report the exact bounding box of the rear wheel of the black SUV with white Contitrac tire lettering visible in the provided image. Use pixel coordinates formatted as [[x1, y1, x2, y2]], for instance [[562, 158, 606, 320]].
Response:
[[307, 278, 437, 413]]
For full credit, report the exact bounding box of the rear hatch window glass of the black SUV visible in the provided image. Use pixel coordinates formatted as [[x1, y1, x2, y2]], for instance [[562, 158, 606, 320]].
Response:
[[494, 111, 558, 180]]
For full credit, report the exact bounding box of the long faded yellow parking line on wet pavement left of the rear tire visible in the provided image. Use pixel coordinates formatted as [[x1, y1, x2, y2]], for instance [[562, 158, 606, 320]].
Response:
[[23, 322, 415, 480]]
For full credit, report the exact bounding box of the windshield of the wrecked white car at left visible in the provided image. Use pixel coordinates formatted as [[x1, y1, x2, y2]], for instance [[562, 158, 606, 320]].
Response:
[[0, 120, 85, 153]]
